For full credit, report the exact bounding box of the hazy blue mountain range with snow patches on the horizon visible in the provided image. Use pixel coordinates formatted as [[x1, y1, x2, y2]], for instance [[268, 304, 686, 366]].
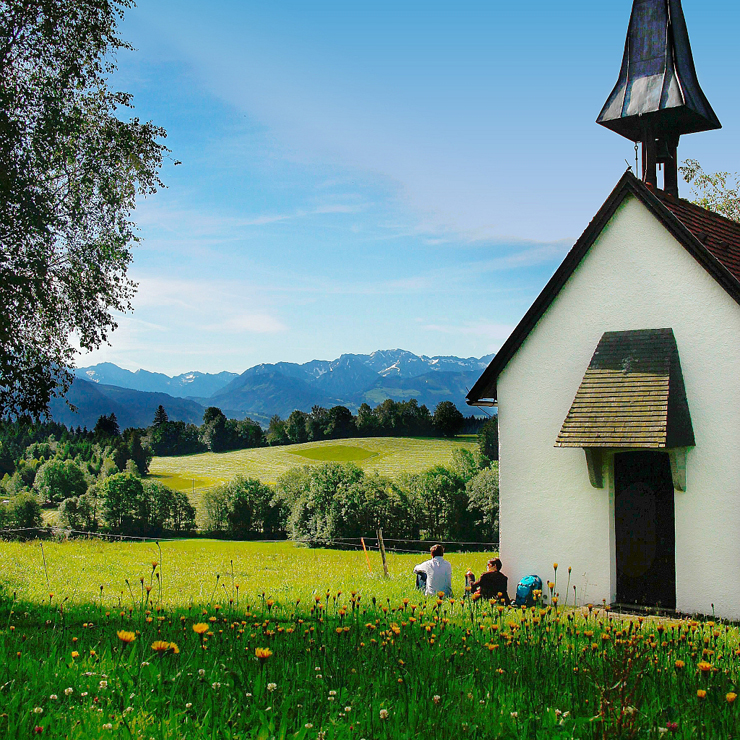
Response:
[[51, 349, 493, 428]]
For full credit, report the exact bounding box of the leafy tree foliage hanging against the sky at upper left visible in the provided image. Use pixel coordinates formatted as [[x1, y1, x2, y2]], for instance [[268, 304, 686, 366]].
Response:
[[0, 0, 166, 418]]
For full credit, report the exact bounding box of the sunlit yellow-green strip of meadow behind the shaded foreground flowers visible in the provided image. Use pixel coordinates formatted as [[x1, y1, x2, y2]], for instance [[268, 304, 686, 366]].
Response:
[[0, 540, 498, 609]]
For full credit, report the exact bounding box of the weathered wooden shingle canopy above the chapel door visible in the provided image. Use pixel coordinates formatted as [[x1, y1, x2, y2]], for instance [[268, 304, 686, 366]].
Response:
[[555, 329, 694, 449]]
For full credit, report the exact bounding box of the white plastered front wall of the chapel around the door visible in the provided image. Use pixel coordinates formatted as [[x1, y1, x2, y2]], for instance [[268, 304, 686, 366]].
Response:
[[498, 196, 740, 619]]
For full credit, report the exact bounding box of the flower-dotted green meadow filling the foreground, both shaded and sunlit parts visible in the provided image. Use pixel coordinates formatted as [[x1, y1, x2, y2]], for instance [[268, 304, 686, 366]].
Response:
[[0, 542, 740, 740]]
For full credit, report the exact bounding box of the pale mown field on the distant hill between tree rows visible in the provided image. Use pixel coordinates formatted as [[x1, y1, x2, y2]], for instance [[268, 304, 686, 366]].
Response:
[[149, 437, 477, 493]]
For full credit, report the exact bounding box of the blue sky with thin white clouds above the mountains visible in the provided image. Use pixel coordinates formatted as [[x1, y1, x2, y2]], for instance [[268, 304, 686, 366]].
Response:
[[78, 0, 740, 374]]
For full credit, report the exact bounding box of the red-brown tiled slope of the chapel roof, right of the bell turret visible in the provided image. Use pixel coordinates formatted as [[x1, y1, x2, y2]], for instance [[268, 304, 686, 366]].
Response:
[[652, 190, 740, 281]]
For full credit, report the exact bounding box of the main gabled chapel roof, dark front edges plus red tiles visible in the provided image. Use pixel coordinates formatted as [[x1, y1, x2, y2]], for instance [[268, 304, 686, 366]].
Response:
[[467, 171, 740, 406]]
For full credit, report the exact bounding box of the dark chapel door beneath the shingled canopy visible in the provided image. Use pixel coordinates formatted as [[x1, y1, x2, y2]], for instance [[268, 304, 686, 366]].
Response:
[[614, 452, 676, 609]]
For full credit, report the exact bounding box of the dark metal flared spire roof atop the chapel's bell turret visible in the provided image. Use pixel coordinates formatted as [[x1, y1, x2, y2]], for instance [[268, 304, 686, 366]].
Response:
[[596, 0, 722, 141]]
